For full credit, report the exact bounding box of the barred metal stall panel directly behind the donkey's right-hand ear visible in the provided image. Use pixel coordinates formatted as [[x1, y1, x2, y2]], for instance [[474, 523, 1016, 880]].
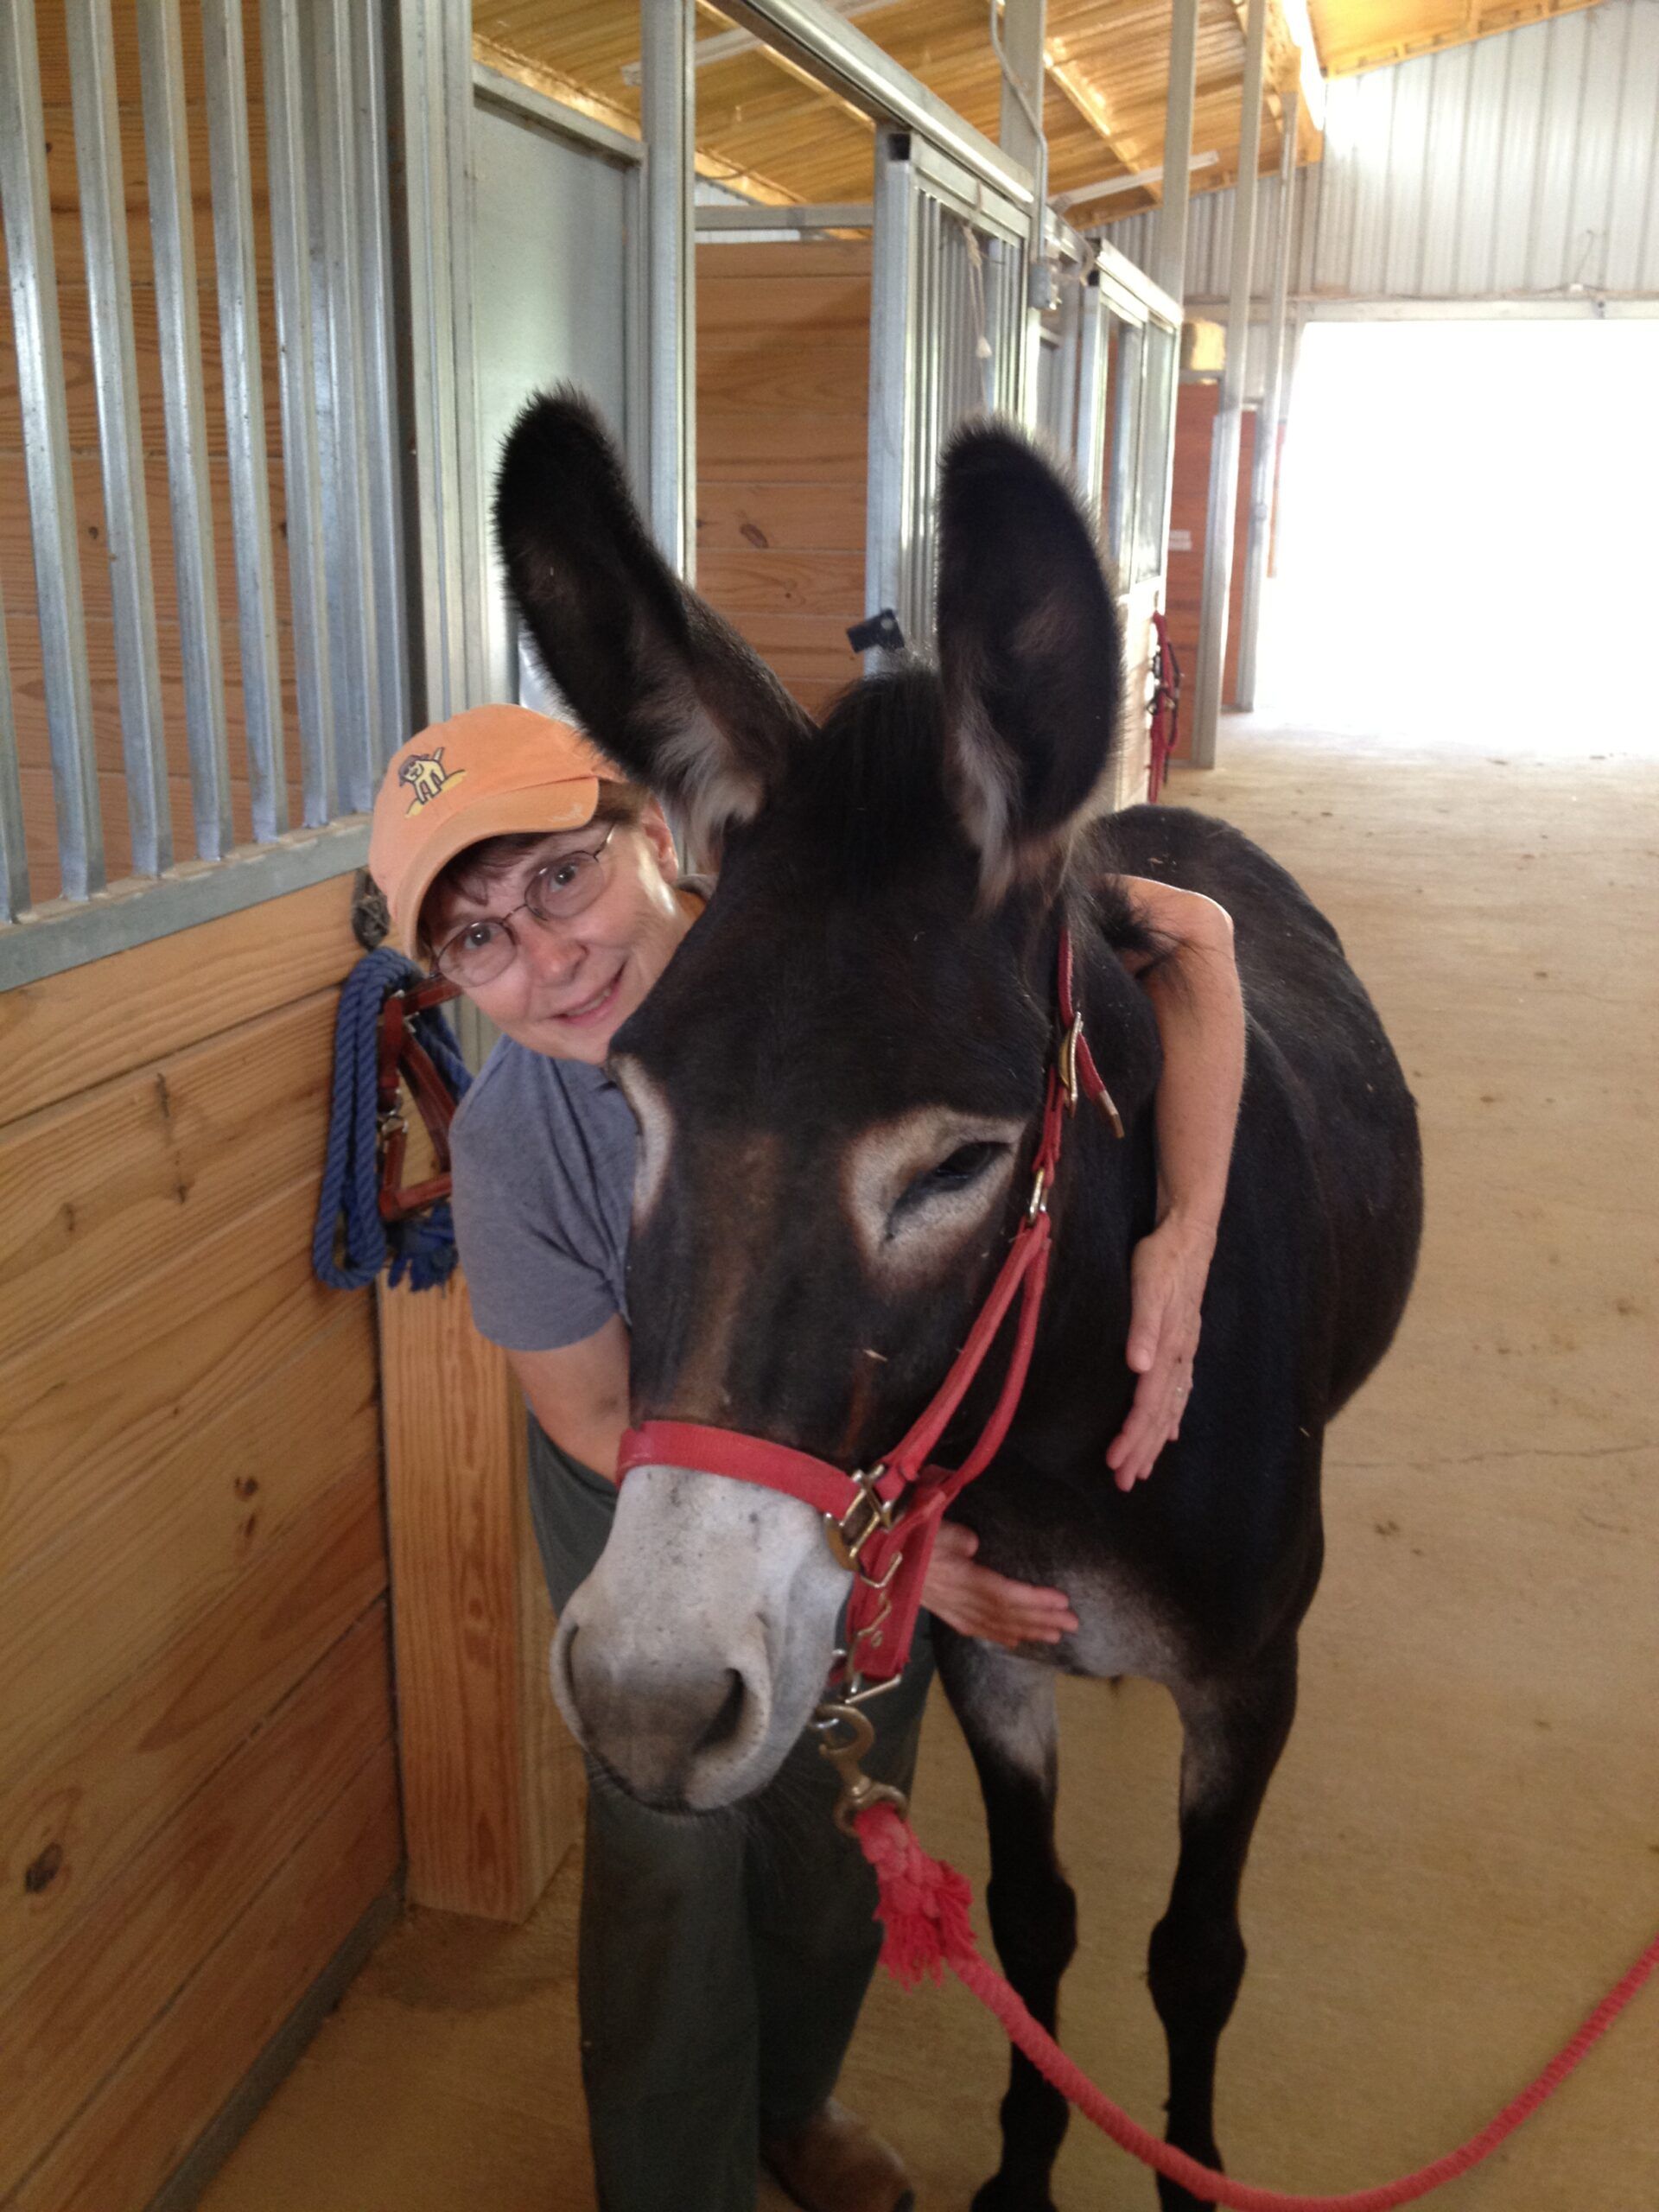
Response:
[[865, 130, 1027, 646]]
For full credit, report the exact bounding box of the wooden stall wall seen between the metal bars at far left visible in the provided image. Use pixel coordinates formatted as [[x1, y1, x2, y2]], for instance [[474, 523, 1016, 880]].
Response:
[[0, 0, 301, 900]]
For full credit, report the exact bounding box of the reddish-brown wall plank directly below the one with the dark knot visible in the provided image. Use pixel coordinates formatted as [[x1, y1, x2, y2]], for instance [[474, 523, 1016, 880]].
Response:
[[0, 1604, 391, 2192]]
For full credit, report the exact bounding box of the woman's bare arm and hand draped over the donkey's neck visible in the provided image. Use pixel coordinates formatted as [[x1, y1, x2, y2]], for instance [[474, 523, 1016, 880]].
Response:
[[1106, 876, 1245, 1491]]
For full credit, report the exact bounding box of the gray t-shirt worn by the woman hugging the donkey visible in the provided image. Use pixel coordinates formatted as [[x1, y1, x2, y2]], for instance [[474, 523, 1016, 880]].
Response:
[[449, 1038, 635, 1351]]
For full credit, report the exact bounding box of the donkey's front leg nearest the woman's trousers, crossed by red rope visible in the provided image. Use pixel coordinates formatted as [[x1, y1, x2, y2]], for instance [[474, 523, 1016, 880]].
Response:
[[936, 1626, 1077, 2212]]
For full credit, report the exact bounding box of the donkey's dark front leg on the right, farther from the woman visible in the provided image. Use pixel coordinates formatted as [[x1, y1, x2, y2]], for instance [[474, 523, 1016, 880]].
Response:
[[1148, 1635, 1296, 2212]]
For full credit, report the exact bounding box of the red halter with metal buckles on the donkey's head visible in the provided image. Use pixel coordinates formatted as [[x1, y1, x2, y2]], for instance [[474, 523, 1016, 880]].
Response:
[[617, 929, 1123, 1688]]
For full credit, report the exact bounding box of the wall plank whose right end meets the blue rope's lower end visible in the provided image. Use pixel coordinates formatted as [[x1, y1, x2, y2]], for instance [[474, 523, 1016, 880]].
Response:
[[0, 1179, 354, 1577]]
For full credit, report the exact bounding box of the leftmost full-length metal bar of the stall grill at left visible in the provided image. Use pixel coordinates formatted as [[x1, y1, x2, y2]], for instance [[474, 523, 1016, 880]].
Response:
[[0, 0, 104, 898]]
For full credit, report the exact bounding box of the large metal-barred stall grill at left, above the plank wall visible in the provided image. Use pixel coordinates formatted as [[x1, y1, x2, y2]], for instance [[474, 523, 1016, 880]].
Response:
[[0, 0, 410, 987]]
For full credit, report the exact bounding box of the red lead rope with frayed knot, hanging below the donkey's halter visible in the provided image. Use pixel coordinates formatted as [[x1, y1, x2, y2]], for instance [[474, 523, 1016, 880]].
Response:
[[854, 1805, 1659, 2212]]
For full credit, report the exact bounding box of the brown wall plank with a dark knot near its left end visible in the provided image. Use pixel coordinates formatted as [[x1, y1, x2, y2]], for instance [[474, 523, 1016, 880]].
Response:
[[0, 1442, 387, 1975]]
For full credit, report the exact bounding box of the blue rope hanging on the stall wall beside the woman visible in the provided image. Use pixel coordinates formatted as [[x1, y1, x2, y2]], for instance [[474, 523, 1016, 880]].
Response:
[[312, 944, 471, 1289]]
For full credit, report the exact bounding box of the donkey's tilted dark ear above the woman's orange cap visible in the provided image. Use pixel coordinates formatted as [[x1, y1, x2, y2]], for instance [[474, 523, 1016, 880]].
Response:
[[495, 385, 812, 845]]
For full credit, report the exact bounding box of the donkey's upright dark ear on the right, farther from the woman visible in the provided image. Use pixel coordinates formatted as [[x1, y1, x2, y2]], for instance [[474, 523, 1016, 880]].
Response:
[[938, 423, 1122, 893]]
